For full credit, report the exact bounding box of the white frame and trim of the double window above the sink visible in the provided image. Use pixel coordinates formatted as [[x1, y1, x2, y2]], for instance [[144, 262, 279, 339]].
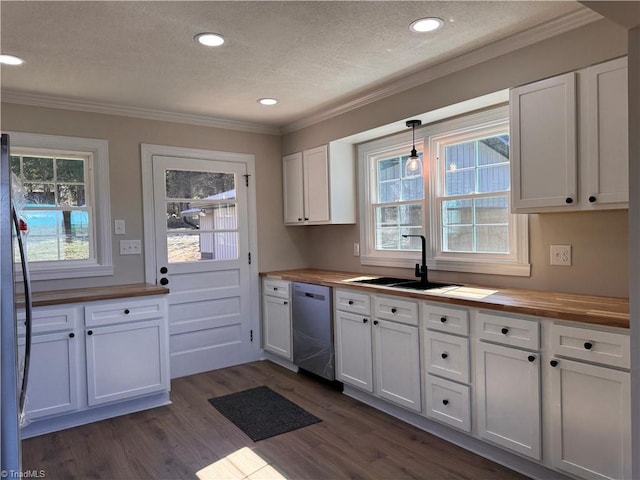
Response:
[[358, 105, 531, 276]]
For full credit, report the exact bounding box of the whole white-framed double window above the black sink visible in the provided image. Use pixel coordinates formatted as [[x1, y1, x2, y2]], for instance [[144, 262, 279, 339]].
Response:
[[359, 107, 530, 275]]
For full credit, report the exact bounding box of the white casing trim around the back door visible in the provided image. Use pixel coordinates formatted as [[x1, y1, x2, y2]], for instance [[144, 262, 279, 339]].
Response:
[[140, 143, 261, 360]]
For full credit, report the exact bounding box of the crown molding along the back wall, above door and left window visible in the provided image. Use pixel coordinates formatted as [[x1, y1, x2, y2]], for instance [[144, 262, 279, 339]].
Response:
[[1, 89, 281, 135]]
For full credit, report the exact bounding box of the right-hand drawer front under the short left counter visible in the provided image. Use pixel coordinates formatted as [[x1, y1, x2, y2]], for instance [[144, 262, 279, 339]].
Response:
[[84, 298, 166, 327]]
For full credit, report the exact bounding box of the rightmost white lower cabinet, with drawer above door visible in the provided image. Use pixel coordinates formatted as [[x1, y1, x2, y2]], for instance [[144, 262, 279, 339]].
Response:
[[546, 324, 631, 479]]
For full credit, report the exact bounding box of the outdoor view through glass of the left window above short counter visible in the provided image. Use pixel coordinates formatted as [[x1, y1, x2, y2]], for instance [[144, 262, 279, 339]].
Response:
[[11, 155, 92, 262]]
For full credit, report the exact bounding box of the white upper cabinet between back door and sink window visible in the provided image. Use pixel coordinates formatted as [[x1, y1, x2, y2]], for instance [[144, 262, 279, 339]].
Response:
[[282, 142, 356, 225]]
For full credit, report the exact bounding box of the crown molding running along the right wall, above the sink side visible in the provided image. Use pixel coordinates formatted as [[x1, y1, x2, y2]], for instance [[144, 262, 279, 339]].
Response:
[[281, 8, 603, 134]]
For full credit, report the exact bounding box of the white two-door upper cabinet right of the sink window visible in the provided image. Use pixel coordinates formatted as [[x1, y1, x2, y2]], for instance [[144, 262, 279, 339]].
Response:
[[510, 58, 629, 213]]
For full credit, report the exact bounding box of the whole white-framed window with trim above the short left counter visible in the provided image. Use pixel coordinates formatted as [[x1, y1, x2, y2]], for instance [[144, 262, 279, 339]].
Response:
[[10, 133, 113, 280]]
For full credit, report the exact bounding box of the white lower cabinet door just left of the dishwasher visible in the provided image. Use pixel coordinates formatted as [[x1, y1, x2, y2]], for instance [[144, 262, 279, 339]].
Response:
[[262, 295, 291, 360]]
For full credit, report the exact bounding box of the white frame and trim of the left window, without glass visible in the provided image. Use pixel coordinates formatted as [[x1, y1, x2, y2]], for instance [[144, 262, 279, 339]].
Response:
[[7, 132, 113, 281]]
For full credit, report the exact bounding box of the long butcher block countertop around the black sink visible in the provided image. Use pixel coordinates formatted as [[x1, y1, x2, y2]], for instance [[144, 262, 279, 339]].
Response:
[[260, 269, 629, 328]]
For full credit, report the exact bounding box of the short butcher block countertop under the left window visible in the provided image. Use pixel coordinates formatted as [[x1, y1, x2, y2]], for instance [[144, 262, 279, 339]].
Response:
[[26, 283, 169, 307]]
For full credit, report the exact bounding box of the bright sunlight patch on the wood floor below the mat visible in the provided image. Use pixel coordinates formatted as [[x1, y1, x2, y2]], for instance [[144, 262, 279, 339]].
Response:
[[196, 447, 287, 480]]
